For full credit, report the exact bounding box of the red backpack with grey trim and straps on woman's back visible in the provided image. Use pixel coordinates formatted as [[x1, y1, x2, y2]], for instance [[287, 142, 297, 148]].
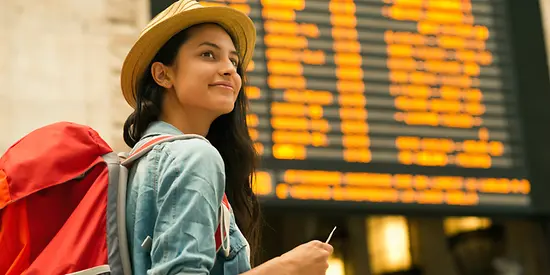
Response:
[[0, 122, 230, 275]]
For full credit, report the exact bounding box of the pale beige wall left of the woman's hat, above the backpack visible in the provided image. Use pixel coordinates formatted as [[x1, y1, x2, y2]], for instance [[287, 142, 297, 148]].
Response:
[[0, 0, 149, 154]]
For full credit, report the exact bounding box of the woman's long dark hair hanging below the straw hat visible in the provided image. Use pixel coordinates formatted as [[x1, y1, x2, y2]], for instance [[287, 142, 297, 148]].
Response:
[[123, 24, 261, 264]]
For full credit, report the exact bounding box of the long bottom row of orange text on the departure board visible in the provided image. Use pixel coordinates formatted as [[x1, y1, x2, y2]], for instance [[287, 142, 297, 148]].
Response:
[[253, 169, 531, 207]]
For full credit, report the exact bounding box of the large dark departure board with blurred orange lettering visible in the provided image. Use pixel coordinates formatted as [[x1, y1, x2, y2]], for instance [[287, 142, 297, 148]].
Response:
[[201, 0, 531, 213]]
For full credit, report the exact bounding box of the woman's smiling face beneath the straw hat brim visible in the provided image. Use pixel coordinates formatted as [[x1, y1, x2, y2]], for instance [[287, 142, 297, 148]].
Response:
[[153, 24, 242, 119]]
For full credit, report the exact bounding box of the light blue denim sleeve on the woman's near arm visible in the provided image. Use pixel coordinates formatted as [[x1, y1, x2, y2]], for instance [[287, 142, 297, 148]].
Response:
[[148, 139, 225, 275]]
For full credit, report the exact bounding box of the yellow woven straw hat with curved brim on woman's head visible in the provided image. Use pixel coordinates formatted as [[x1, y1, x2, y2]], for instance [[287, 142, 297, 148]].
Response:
[[120, 0, 256, 108]]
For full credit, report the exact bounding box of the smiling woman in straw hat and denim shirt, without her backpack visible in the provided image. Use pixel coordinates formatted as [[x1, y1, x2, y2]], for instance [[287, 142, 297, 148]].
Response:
[[121, 0, 332, 275]]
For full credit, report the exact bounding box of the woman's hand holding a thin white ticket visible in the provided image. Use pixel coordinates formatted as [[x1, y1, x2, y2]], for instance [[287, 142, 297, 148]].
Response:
[[279, 241, 334, 275]]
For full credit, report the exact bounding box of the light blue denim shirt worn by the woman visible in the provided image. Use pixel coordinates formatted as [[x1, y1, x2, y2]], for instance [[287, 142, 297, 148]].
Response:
[[126, 121, 250, 275]]
